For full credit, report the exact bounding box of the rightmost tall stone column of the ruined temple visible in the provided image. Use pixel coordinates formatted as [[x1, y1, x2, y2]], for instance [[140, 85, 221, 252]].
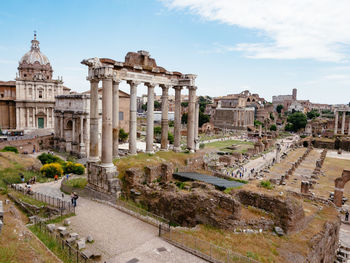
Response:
[[187, 86, 197, 151]]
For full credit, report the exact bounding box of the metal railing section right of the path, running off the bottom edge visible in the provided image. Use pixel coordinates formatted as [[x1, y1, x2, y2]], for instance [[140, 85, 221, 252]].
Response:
[[158, 224, 259, 263]]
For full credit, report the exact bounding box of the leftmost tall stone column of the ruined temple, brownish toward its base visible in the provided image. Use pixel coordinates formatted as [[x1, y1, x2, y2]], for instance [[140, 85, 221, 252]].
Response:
[[89, 79, 100, 162]]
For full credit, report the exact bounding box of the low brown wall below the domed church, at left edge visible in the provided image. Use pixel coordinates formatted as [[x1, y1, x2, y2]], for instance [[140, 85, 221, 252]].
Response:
[[0, 135, 53, 153]]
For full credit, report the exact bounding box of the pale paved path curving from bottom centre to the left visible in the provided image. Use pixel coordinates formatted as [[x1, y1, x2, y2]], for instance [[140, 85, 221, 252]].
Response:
[[33, 182, 206, 263]]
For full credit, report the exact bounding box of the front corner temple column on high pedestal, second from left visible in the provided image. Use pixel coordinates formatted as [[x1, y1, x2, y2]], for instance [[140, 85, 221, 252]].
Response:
[[101, 71, 113, 167]]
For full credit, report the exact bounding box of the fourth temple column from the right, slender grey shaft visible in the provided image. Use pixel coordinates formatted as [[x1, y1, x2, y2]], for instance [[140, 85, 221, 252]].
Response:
[[145, 83, 155, 153]]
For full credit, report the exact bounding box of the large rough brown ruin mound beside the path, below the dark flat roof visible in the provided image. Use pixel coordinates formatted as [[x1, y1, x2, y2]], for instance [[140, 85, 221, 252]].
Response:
[[133, 186, 241, 228]]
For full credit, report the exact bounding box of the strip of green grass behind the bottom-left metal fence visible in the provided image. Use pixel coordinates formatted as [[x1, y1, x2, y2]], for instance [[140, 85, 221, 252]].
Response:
[[29, 225, 76, 263]]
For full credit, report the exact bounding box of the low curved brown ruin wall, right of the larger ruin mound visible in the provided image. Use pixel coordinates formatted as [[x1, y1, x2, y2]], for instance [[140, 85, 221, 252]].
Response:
[[236, 190, 305, 233]]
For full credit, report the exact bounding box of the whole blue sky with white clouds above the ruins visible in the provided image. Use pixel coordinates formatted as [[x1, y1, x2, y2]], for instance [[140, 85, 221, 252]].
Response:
[[0, 0, 350, 103]]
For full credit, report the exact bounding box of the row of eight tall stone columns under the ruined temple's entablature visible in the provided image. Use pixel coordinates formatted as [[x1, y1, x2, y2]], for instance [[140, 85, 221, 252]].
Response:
[[89, 74, 199, 166]]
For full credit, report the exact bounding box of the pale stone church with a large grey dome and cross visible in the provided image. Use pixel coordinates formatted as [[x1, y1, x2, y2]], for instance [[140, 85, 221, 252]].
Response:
[[15, 34, 70, 131]]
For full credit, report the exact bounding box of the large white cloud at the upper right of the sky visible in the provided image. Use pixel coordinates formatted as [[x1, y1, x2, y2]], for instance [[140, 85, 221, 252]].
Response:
[[161, 0, 350, 62]]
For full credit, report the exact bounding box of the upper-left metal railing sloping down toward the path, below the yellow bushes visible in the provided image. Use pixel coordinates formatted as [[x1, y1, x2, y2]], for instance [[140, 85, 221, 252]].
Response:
[[11, 184, 75, 214]]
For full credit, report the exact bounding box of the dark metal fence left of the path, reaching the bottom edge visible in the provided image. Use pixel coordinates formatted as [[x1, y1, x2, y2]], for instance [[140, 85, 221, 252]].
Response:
[[33, 220, 95, 263]]
